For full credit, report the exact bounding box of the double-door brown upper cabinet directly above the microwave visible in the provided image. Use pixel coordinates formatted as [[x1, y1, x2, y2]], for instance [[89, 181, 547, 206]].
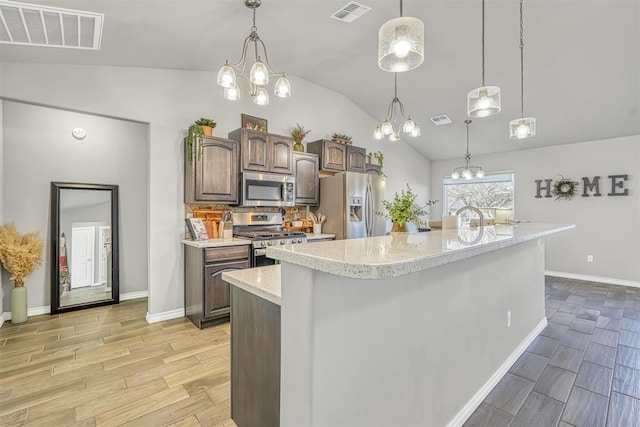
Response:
[[229, 129, 293, 175]]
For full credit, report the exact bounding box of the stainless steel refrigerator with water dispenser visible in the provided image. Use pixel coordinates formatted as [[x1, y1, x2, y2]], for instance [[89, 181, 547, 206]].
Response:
[[318, 172, 387, 239]]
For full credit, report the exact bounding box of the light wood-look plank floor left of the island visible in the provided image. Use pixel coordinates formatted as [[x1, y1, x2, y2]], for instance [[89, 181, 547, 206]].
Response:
[[0, 298, 235, 427]]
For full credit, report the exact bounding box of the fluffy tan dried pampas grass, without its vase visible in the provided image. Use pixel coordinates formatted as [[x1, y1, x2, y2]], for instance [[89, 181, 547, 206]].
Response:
[[0, 224, 44, 288]]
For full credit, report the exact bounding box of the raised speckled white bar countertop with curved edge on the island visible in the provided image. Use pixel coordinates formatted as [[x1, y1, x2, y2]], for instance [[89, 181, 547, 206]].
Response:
[[267, 223, 575, 279]]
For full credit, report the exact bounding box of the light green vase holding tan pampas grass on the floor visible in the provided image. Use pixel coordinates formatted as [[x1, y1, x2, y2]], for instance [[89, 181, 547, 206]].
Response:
[[0, 224, 44, 323]]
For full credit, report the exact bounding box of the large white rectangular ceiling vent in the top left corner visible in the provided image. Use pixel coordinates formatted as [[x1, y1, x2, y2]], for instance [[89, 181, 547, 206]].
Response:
[[0, 0, 104, 50]]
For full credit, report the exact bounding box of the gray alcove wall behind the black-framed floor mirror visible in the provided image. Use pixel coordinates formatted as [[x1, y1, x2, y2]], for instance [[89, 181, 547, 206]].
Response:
[[2, 102, 148, 311]]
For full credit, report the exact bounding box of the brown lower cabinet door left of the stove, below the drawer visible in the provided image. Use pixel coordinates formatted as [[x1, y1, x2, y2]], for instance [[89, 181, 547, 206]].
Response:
[[204, 260, 249, 319]]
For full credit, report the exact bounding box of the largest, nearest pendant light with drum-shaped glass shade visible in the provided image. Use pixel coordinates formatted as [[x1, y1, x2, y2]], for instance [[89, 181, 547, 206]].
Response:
[[378, 0, 424, 73]]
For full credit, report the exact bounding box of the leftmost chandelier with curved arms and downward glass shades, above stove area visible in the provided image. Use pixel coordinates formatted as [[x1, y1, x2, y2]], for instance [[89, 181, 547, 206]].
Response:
[[217, 0, 291, 105]]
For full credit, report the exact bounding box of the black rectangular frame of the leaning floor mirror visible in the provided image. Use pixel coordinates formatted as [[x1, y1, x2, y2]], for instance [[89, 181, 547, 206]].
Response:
[[49, 182, 120, 314]]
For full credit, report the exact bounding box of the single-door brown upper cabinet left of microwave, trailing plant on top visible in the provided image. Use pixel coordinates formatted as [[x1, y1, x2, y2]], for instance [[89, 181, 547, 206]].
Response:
[[184, 136, 238, 204]]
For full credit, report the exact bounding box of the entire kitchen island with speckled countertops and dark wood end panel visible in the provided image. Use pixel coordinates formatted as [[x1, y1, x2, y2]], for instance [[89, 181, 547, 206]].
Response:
[[223, 223, 574, 427]]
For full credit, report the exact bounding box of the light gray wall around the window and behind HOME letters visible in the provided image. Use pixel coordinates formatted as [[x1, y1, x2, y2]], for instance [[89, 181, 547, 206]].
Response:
[[431, 135, 640, 285]]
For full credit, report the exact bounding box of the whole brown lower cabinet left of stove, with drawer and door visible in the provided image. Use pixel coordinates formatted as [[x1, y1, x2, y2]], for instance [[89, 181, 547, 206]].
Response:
[[184, 245, 249, 328]]
